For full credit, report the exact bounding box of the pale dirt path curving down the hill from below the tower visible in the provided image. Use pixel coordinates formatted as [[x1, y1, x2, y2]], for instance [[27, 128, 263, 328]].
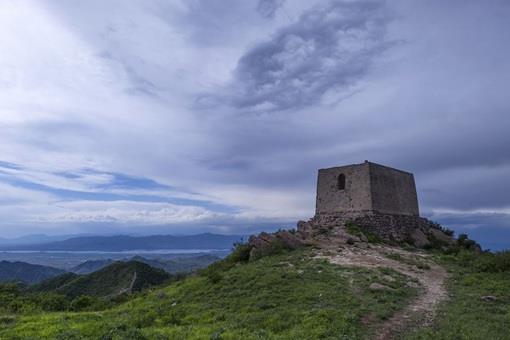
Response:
[[318, 246, 447, 340]]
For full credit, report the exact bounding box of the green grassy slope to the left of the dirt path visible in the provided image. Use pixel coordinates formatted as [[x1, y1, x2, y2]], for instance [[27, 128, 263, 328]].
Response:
[[0, 249, 416, 340]]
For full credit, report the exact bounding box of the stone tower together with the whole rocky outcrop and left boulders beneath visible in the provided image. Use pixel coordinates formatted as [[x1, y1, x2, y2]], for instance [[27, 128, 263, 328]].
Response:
[[249, 161, 455, 252]]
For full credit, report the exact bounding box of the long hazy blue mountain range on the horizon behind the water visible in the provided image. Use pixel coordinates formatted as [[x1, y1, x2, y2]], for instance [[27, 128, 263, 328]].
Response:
[[0, 234, 242, 251]]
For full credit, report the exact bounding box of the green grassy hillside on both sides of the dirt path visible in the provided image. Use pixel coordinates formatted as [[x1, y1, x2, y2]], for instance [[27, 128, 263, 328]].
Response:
[[0, 244, 510, 340]]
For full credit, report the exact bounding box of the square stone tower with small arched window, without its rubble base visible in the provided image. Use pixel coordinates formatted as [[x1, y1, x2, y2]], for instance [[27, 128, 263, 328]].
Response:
[[315, 161, 419, 216]]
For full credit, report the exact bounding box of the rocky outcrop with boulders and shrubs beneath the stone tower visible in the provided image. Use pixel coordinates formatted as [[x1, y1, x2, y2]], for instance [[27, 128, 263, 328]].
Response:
[[249, 213, 456, 260]]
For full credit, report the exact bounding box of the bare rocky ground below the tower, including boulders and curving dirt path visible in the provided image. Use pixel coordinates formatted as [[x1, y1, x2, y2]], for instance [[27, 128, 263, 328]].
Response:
[[250, 219, 453, 340]]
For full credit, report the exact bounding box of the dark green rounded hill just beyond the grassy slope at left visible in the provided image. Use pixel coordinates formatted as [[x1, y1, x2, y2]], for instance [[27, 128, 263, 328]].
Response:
[[31, 261, 171, 298]]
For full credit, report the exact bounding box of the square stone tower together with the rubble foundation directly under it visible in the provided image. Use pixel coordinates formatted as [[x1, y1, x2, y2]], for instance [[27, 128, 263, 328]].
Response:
[[298, 161, 451, 247]]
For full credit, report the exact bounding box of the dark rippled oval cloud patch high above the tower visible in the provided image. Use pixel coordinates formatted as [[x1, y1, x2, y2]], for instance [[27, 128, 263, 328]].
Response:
[[230, 1, 391, 112]]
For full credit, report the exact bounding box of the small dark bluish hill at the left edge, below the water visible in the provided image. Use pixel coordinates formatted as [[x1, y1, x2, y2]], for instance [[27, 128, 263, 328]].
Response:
[[0, 261, 65, 284]]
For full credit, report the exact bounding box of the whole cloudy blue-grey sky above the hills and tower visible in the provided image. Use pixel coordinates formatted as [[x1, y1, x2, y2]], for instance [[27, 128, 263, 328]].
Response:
[[0, 0, 510, 249]]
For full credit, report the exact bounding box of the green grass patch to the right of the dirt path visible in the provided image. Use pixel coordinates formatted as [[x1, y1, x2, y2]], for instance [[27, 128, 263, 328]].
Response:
[[404, 252, 510, 340]]
